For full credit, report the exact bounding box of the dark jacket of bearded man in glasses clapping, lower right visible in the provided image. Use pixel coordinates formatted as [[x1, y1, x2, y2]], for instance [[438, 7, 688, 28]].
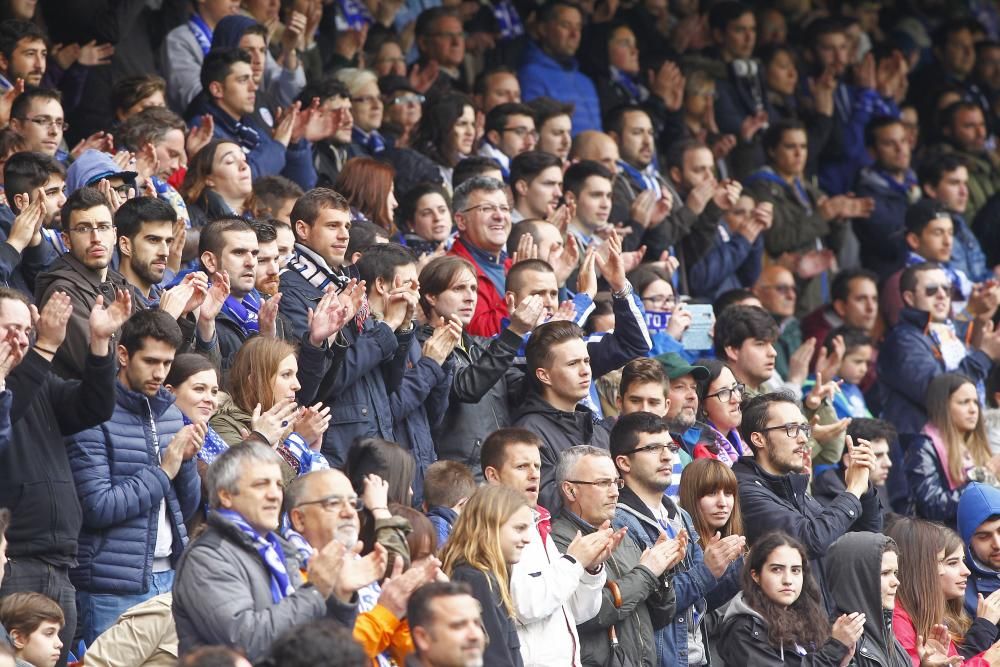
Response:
[[733, 456, 882, 611]]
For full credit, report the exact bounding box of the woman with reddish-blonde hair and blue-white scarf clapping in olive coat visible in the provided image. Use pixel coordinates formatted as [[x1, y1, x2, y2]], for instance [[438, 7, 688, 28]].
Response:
[[208, 336, 330, 483]]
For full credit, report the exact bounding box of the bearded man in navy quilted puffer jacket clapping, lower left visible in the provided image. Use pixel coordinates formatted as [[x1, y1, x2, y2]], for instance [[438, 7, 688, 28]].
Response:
[[68, 310, 206, 644]]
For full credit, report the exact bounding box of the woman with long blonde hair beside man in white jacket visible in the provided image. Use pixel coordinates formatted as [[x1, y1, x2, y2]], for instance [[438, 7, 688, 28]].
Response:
[[441, 485, 535, 667]]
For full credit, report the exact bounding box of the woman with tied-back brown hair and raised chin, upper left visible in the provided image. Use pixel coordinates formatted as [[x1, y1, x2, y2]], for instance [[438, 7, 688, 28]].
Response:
[[180, 139, 253, 227]]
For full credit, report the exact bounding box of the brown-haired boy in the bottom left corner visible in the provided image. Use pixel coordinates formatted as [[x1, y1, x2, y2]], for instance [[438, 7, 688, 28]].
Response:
[[0, 593, 65, 667]]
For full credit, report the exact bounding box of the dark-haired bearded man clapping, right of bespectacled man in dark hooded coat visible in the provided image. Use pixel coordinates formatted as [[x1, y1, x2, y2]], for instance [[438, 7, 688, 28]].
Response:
[[115, 197, 228, 357]]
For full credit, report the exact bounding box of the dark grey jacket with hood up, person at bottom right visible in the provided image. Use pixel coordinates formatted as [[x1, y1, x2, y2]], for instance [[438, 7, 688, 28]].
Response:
[[827, 533, 912, 667]]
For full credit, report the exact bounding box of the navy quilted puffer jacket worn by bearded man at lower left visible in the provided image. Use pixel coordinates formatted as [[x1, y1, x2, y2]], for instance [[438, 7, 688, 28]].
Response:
[[68, 382, 201, 595]]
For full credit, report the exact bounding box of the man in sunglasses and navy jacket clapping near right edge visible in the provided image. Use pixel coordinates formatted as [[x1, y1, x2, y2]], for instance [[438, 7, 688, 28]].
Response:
[[878, 262, 1000, 507]]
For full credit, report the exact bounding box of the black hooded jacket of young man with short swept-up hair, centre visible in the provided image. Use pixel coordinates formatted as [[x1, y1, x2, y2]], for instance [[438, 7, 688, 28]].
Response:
[[514, 392, 611, 511]]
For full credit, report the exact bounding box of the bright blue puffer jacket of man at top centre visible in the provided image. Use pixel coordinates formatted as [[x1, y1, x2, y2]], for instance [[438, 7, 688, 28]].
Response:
[[517, 40, 601, 136]]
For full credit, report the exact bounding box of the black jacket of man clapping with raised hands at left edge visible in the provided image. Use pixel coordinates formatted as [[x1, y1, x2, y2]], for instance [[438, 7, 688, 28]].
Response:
[[0, 350, 115, 567]]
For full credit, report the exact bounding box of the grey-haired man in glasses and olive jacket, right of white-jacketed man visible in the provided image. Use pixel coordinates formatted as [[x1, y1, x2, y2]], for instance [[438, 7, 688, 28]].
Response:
[[552, 445, 687, 665]]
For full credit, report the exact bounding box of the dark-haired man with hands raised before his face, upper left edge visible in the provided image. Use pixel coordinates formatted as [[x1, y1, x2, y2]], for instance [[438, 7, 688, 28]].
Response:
[[0, 152, 66, 297]]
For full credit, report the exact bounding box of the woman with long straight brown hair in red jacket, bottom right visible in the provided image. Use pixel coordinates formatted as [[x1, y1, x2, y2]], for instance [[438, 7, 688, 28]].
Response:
[[886, 517, 1000, 667]]
